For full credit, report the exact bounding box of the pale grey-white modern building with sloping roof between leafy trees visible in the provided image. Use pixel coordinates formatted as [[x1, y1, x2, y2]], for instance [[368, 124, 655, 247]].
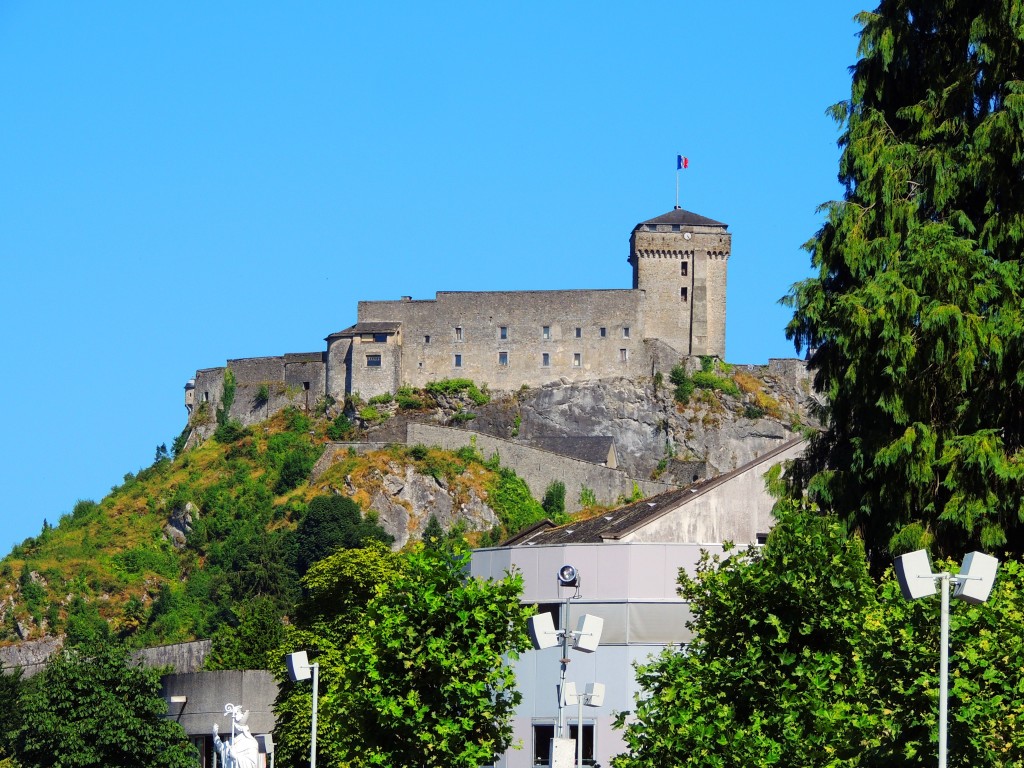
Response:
[[471, 439, 805, 768]]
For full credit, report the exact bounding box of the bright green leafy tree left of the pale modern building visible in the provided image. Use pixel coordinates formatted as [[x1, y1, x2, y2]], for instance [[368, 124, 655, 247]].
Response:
[[278, 544, 529, 768]]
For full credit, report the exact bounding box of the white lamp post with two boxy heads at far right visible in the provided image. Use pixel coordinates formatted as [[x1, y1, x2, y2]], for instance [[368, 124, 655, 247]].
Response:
[[896, 549, 999, 768]]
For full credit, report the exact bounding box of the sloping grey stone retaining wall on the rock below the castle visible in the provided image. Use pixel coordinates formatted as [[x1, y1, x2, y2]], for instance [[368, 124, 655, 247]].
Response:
[[406, 423, 675, 512]]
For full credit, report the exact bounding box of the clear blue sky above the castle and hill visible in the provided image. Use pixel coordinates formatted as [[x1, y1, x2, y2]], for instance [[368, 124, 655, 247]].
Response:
[[0, 0, 870, 553]]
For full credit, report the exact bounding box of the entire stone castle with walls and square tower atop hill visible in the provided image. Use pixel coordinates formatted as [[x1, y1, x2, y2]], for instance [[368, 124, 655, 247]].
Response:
[[185, 207, 731, 423]]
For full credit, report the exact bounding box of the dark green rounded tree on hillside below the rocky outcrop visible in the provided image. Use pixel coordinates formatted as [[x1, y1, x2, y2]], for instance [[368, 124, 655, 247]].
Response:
[[296, 494, 394, 573]]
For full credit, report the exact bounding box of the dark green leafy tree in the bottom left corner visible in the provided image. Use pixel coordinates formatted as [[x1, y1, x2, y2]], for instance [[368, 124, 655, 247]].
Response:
[[17, 644, 197, 768]]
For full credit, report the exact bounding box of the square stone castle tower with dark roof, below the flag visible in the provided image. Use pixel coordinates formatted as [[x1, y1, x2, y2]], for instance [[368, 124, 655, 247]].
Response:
[[629, 208, 732, 359]]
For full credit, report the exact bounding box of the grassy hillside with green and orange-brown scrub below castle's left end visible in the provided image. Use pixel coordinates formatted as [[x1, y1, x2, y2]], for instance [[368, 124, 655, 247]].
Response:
[[0, 399, 543, 646]]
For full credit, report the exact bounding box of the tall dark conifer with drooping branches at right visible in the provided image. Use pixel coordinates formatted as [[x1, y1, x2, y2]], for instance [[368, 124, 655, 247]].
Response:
[[785, 0, 1024, 572]]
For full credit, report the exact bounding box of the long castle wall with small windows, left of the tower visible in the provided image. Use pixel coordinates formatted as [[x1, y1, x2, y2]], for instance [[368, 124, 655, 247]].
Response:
[[352, 290, 650, 395]]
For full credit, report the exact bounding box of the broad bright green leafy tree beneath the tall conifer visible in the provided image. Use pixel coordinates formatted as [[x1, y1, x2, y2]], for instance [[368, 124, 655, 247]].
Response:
[[614, 511, 1024, 768]]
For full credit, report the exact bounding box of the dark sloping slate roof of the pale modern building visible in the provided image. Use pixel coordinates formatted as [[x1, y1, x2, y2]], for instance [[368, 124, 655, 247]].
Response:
[[502, 437, 806, 547]]
